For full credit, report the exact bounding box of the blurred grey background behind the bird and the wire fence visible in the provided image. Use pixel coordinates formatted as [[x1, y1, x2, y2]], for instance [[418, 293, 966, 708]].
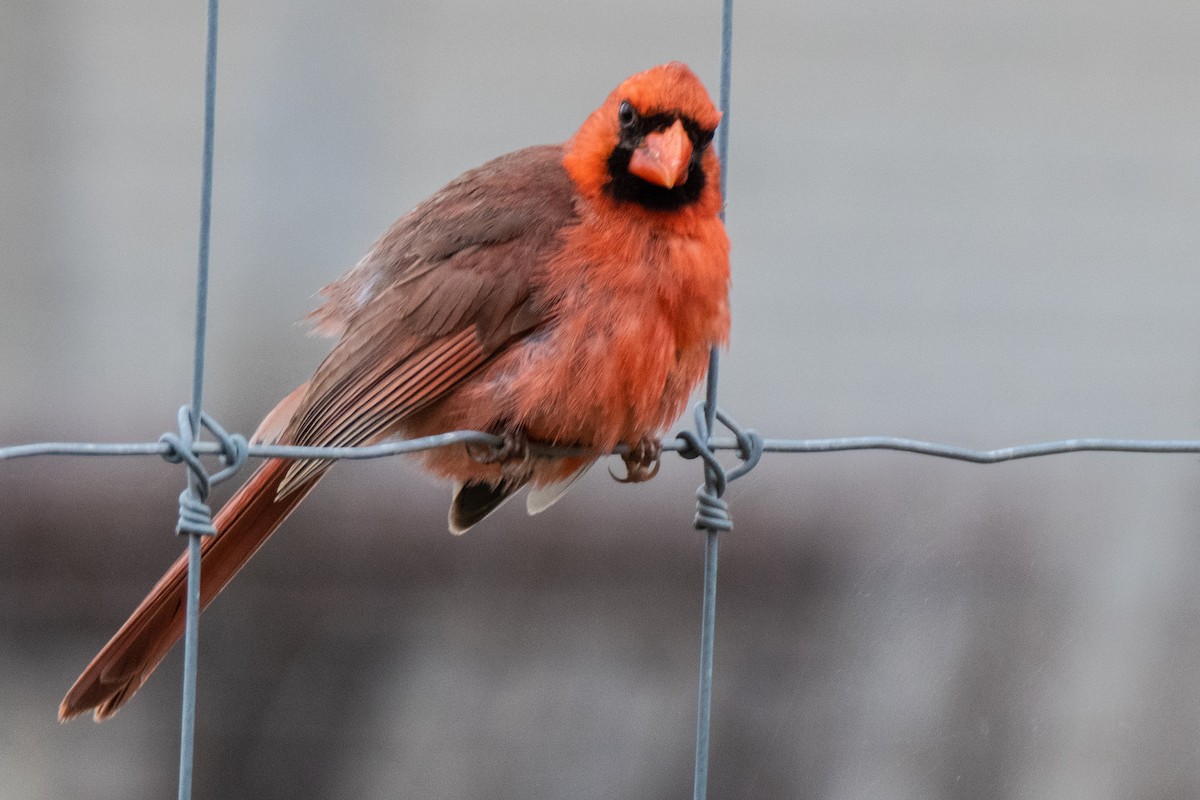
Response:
[[0, 0, 1200, 800]]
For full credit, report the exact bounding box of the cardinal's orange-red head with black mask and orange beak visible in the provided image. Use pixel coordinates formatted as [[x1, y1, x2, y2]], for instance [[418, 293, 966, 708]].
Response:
[[563, 61, 721, 213]]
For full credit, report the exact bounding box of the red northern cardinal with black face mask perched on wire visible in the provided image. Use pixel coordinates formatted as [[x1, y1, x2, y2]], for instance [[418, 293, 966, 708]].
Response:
[[59, 62, 730, 721]]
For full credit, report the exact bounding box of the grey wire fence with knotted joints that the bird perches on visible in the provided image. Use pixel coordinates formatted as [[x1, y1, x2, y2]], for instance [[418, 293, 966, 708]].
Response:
[[0, 0, 1200, 800]]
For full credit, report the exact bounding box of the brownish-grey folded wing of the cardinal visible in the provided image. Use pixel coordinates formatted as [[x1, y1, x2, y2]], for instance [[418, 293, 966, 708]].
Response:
[[280, 145, 576, 495]]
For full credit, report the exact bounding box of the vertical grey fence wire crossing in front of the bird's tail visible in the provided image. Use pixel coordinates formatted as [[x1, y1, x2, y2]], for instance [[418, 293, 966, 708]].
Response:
[[179, 0, 217, 800]]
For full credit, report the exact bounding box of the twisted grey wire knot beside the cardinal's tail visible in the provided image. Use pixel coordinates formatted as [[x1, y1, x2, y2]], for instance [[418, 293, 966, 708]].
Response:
[[158, 405, 250, 536]]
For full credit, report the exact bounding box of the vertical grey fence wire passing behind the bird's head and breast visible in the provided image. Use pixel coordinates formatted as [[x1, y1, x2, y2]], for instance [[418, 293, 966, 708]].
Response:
[[692, 0, 733, 800]]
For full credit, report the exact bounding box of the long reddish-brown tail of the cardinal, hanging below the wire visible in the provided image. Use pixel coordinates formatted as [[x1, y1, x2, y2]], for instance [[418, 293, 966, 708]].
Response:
[[59, 459, 324, 722]]
